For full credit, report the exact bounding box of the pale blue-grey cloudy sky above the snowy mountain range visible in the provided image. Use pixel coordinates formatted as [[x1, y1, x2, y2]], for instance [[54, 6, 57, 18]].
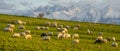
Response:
[[0, 0, 120, 15]]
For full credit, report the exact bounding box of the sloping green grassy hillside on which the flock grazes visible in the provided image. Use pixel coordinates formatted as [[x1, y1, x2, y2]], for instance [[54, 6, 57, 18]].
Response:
[[0, 14, 120, 51]]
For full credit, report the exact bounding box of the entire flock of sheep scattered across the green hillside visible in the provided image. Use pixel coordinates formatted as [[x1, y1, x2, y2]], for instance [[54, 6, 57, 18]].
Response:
[[4, 20, 118, 47]]
